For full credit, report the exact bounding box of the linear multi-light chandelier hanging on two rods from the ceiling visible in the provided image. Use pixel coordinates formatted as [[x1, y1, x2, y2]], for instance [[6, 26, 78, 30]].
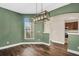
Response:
[[32, 3, 49, 22]]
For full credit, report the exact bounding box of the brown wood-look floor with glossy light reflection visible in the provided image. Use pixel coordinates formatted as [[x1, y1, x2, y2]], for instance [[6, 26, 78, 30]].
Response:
[[0, 43, 76, 56]]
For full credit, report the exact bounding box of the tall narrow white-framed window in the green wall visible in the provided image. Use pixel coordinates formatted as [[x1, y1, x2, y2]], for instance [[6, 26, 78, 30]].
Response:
[[24, 18, 34, 39]]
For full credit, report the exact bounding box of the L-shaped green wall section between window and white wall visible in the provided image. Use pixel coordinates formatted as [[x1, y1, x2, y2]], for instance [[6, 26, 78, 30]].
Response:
[[34, 21, 49, 43]]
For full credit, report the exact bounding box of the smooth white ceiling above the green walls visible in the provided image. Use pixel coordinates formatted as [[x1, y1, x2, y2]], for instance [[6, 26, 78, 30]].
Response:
[[0, 3, 69, 14]]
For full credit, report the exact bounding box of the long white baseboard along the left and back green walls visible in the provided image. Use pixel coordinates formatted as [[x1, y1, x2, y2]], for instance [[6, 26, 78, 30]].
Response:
[[0, 42, 50, 50]]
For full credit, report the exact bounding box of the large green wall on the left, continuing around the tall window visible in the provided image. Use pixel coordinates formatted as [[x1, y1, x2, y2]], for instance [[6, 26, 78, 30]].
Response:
[[0, 8, 49, 47]]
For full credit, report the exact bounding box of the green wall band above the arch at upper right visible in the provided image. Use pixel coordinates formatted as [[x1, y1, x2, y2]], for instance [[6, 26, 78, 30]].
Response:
[[49, 3, 79, 17]]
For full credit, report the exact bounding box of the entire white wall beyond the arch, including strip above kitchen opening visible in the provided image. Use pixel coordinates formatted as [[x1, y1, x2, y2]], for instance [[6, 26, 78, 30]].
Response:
[[44, 13, 79, 44]]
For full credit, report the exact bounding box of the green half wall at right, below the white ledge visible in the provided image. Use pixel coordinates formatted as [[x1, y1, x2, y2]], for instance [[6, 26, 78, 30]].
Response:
[[68, 34, 79, 51]]
